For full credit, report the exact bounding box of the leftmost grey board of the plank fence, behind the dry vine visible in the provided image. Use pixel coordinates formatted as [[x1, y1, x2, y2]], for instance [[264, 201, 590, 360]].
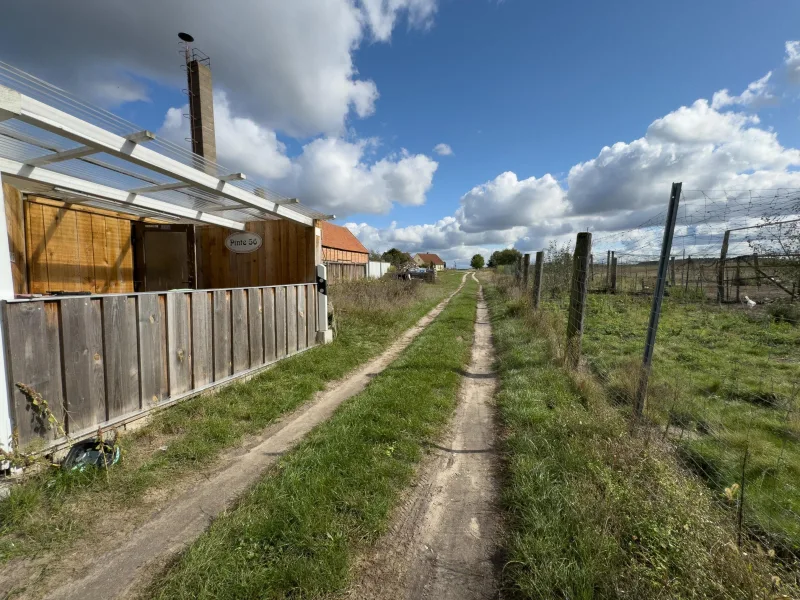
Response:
[[5, 302, 62, 442]]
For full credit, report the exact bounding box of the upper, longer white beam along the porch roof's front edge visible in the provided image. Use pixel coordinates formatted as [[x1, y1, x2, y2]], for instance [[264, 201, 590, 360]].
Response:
[[0, 86, 314, 227]]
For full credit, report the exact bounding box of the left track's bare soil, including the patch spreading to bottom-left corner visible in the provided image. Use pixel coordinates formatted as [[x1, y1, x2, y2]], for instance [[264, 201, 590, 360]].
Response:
[[0, 275, 466, 600]]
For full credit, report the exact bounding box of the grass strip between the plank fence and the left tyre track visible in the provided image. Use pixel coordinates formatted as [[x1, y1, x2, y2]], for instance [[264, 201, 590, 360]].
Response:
[[0, 273, 461, 561]]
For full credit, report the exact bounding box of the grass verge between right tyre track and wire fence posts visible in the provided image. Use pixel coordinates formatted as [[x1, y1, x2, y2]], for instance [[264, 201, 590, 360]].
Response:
[[486, 285, 797, 599]]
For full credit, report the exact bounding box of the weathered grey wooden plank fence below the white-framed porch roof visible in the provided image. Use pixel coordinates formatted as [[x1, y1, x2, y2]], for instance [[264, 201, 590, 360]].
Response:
[[2, 284, 317, 449]]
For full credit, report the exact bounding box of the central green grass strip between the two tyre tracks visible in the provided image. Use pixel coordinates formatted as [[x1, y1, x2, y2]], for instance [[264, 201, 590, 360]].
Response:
[[147, 279, 477, 599]]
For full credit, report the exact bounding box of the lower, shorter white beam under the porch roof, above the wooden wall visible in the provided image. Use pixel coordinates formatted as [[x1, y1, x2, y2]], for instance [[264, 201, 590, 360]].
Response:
[[0, 158, 244, 230]]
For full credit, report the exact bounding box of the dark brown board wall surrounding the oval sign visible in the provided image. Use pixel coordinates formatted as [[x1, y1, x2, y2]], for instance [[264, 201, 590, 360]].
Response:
[[195, 220, 318, 289]]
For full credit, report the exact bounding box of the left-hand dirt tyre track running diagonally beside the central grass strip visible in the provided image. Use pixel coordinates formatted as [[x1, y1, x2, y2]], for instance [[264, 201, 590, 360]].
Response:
[[37, 274, 467, 600]]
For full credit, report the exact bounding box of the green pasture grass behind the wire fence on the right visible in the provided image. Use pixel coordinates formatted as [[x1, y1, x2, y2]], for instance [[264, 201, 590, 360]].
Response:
[[568, 296, 800, 555]]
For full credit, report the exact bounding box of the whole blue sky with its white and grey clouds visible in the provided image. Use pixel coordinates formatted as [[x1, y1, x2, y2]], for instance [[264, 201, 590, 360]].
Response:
[[0, 0, 800, 262]]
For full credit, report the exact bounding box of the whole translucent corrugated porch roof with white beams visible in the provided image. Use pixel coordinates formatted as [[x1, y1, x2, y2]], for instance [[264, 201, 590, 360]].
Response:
[[0, 62, 332, 230]]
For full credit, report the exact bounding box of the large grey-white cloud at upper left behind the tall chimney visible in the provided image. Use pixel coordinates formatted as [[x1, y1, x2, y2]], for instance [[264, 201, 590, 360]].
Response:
[[0, 0, 436, 135]]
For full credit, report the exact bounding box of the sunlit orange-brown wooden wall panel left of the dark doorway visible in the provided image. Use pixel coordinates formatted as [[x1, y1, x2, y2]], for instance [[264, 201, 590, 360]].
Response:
[[24, 198, 133, 294]]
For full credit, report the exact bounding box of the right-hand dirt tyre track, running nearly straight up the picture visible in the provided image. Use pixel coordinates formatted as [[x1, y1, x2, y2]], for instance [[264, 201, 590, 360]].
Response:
[[346, 275, 500, 600]]
